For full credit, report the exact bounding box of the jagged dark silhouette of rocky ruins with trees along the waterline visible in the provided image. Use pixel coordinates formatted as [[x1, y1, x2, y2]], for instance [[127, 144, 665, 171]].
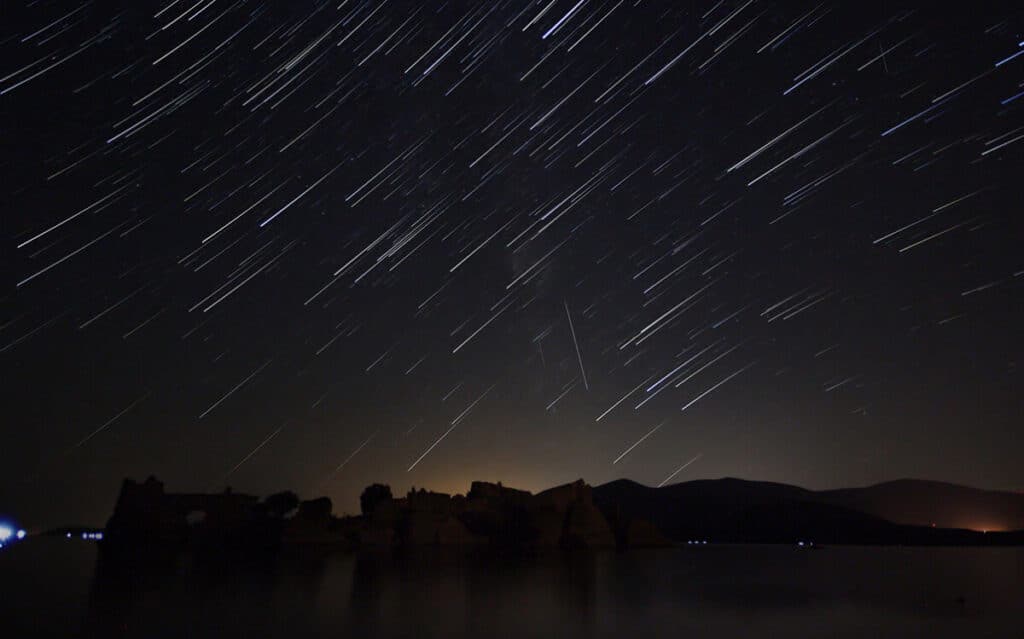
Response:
[[99, 477, 664, 550]]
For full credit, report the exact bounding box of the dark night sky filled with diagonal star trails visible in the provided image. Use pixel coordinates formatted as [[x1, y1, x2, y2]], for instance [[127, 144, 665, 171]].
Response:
[[0, 0, 1024, 525]]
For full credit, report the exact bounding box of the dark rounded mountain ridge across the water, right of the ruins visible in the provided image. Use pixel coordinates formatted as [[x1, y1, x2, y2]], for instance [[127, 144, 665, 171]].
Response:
[[594, 477, 1024, 543]]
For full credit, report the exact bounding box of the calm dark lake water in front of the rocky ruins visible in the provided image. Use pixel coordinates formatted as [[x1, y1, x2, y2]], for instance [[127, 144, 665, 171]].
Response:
[[0, 539, 1024, 638]]
